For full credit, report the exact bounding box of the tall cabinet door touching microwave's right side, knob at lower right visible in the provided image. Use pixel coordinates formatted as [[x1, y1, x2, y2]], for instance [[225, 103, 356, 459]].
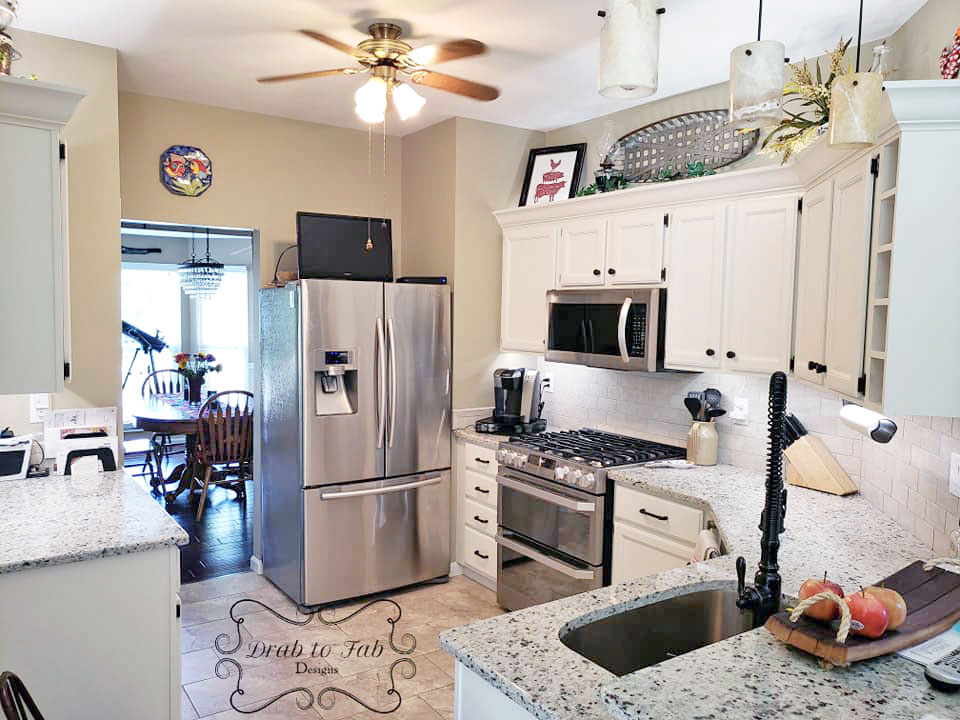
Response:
[[664, 204, 727, 370]]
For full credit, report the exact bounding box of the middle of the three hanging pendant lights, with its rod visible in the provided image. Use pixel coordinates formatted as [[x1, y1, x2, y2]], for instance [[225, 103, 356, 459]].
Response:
[[730, 0, 786, 130]]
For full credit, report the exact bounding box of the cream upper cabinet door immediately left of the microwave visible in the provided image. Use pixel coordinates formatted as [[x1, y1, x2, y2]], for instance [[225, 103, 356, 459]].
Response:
[[500, 223, 559, 353]]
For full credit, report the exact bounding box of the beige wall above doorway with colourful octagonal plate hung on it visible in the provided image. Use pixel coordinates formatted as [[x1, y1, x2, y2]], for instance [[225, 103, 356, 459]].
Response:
[[117, 93, 401, 285]]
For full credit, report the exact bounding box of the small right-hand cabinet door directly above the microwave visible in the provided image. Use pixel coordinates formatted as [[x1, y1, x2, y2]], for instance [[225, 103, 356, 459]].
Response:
[[605, 210, 666, 285]]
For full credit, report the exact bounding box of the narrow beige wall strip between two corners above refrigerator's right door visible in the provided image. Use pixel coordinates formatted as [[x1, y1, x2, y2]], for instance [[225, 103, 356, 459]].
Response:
[[400, 119, 457, 285]]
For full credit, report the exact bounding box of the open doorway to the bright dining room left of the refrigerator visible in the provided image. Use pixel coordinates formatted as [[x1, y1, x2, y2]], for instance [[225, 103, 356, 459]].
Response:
[[121, 220, 259, 583]]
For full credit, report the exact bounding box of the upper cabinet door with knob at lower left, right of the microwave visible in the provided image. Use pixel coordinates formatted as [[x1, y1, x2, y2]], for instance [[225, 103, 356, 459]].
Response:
[[723, 195, 798, 372]]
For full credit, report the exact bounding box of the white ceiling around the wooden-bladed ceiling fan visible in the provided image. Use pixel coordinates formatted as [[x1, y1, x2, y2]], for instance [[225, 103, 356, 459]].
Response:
[[15, 0, 924, 134]]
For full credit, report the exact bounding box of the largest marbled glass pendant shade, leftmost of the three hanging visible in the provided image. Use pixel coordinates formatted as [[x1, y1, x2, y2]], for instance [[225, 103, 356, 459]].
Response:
[[597, 0, 661, 98]]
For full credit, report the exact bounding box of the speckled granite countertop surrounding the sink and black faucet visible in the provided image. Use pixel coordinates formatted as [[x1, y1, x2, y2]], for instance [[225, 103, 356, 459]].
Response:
[[440, 465, 958, 720]]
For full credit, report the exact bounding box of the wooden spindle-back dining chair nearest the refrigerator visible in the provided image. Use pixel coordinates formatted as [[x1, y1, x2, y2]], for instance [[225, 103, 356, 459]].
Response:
[[193, 390, 253, 520]]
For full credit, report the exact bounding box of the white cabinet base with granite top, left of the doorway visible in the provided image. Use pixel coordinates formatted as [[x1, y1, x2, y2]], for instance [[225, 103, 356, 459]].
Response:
[[0, 472, 189, 720]]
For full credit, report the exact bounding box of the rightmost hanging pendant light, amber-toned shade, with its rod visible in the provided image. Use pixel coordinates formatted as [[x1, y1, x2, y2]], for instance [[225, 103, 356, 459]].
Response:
[[830, 0, 883, 150]]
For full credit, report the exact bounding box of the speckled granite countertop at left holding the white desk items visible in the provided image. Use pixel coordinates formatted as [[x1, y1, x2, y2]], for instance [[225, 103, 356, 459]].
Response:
[[0, 471, 190, 573]]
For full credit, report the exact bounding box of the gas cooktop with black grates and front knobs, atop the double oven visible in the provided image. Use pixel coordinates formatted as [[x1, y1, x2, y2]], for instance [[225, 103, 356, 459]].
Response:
[[497, 428, 686, 495]]
